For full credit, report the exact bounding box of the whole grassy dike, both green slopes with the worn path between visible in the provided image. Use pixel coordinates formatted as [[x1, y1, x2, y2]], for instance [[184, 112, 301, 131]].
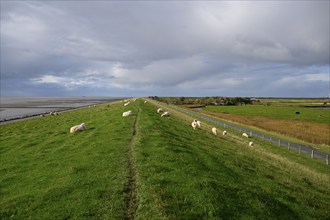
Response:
[[0, 101, 330, 219]]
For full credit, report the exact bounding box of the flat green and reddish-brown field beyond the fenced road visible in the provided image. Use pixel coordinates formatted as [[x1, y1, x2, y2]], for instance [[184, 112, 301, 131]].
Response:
[[204, 105, 330, 148]]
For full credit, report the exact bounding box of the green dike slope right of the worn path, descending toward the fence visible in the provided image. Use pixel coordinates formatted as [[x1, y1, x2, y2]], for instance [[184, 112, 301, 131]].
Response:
[[136, 101, 330, 219]]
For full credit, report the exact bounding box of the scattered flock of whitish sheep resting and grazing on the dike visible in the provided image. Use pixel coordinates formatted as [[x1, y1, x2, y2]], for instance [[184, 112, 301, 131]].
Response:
[[70, 99, 254, 147]]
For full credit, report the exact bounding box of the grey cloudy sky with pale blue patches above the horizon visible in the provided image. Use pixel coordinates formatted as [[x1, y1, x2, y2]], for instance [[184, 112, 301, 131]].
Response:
[[1, 0, 330, 97]]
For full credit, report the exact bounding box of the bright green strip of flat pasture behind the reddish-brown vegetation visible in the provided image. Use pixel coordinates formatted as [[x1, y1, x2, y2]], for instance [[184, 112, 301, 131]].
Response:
[[205, 105, 330, 124]]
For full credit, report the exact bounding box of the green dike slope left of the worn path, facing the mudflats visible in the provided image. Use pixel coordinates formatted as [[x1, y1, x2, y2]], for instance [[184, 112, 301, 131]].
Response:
[[0, 104, 134, 219]]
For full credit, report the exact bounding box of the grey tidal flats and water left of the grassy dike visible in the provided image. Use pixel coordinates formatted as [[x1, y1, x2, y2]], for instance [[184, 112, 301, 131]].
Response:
[[0, 96, 127, 122]]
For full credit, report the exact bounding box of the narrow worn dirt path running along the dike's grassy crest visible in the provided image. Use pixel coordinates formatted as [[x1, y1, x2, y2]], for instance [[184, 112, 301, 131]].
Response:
[[123, 108, 140, 220]]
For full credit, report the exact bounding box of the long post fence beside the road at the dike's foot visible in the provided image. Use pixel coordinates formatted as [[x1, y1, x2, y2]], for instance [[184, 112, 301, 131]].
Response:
[[159, 103, 329, 165]]
